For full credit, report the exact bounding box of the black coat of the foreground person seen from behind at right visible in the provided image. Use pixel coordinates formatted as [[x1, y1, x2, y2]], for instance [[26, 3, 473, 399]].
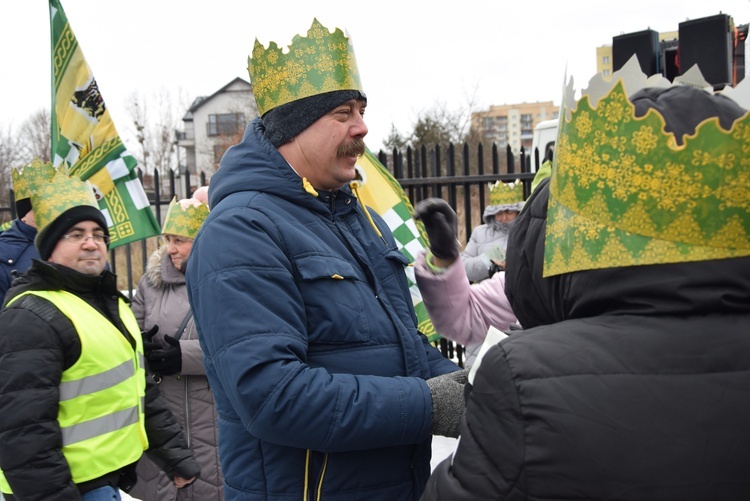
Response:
[[422, 184, 750, 501]]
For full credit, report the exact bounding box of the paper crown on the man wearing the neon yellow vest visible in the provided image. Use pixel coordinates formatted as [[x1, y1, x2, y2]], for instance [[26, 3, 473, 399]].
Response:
[[31, 169, 99, 234]]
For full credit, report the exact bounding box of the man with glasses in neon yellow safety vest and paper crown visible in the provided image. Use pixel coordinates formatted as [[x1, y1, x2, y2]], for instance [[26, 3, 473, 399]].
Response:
[[0, 173, 199, 501]]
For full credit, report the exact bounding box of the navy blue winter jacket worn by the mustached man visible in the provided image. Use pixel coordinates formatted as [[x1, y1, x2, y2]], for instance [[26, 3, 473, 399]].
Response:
[[187, 119, 458, 501]]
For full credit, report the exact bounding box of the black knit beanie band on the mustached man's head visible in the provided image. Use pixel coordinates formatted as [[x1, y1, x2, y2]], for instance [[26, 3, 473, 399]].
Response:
[[263, 90, 367, 148]]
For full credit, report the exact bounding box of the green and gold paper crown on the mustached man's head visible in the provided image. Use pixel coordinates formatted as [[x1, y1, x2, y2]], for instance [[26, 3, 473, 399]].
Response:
[[247, 19, 362, 116]]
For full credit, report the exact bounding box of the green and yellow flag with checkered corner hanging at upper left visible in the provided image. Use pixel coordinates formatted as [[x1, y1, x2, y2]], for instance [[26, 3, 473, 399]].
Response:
[[49, 0, 160, 248]]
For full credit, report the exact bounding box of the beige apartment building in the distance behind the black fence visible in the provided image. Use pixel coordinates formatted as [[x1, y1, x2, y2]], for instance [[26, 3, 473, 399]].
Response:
[[471, 101, 560, 153]]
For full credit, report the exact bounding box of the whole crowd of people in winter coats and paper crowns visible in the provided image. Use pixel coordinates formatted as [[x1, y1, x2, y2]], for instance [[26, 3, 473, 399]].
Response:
[[0, 15, 750, 501]]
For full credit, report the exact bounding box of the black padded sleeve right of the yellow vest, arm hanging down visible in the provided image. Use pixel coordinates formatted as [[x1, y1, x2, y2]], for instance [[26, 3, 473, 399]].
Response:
[[145, 376, 200, 478]]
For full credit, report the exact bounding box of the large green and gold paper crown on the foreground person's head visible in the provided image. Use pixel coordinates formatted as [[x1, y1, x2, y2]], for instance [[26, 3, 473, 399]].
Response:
[[543, 59, 750, 276]]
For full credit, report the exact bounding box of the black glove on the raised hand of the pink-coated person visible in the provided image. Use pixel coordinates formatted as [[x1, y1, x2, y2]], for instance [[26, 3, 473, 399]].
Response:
[[414, 198, 458, 260]]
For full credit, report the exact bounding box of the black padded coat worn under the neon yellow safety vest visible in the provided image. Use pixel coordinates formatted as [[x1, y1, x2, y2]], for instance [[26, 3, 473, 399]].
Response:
[[0, 260, 199, 501]]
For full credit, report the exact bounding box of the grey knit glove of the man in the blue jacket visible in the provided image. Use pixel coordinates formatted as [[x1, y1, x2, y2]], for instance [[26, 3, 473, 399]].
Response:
[[427, 369, 469, 438]]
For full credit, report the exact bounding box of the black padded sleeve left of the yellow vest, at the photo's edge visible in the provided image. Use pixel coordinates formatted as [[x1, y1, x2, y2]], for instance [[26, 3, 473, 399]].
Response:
[[0, 296, 81, 501]]
